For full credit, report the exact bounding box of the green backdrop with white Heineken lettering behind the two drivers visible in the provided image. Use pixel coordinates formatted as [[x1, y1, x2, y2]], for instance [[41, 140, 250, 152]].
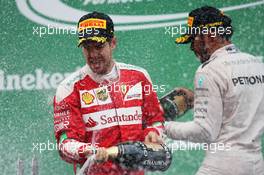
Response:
[[0, 0, 264, 175]]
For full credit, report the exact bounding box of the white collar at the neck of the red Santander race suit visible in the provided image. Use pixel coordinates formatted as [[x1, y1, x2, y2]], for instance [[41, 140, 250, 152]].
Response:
[[85, 62, 120, 85]]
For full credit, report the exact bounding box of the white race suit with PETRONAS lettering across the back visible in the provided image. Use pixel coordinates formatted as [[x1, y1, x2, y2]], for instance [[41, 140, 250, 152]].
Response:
[[165, 44, 264, 175]]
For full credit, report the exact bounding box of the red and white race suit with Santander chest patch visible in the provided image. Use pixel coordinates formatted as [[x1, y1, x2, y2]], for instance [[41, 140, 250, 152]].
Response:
[[54, 63, 164, 175]]
